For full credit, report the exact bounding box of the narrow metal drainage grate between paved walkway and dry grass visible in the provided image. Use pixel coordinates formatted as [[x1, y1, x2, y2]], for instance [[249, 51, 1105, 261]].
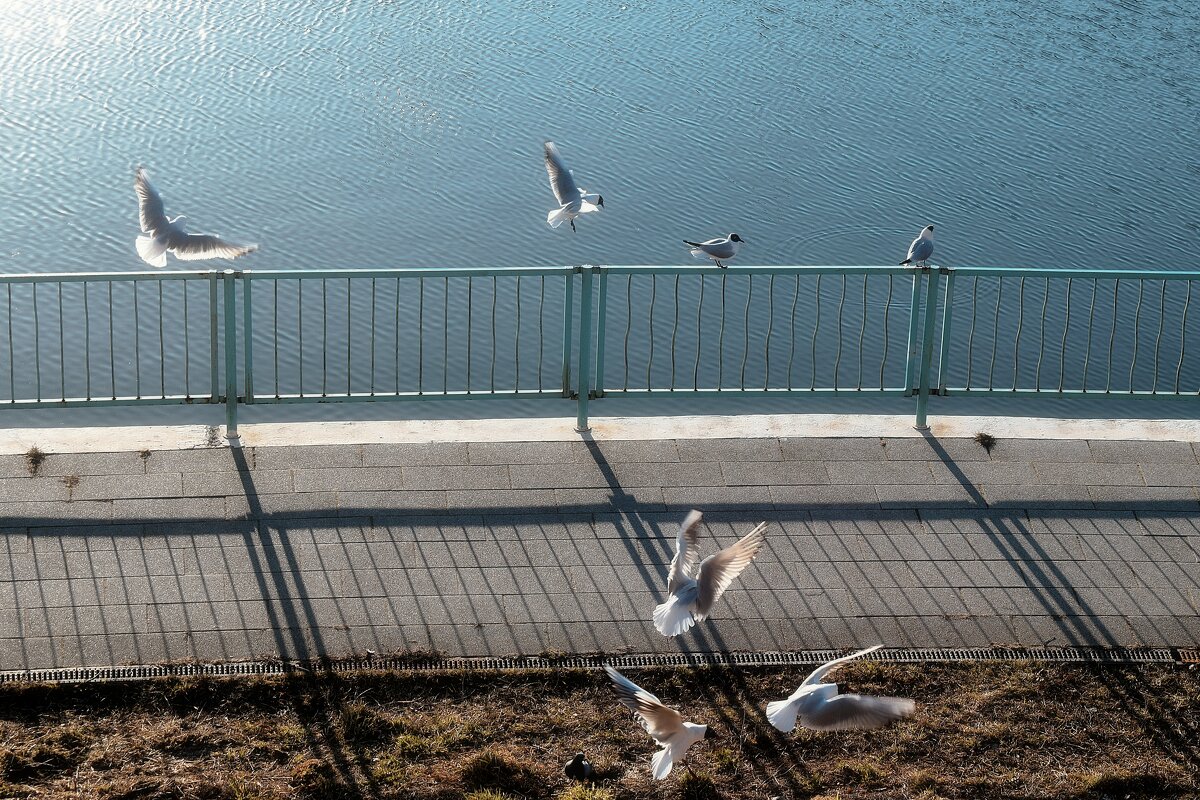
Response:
[[0, 648, 1180, 684]]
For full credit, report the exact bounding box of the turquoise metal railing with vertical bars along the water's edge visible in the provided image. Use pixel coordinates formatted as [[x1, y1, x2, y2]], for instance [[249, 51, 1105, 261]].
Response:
[[0, 266, 1200, 438]]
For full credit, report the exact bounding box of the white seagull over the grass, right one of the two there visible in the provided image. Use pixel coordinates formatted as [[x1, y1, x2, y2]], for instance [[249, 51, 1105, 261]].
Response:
[[767, 644, 917, 733]]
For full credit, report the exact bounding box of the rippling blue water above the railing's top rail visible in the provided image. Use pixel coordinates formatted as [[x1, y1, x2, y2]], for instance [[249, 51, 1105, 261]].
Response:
[[0, 0, 1200, 424]]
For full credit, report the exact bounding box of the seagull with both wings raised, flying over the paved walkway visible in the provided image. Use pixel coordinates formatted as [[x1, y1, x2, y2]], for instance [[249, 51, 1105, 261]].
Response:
[[654, 510, 767, 636]]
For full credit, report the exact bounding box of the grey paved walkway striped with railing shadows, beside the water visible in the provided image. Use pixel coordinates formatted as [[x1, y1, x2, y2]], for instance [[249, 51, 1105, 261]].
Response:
[[0, 420, 1200, 669]]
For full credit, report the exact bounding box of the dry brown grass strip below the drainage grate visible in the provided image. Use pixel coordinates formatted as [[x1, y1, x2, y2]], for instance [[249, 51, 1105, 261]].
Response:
[[0, 662, 1200, 800]]
